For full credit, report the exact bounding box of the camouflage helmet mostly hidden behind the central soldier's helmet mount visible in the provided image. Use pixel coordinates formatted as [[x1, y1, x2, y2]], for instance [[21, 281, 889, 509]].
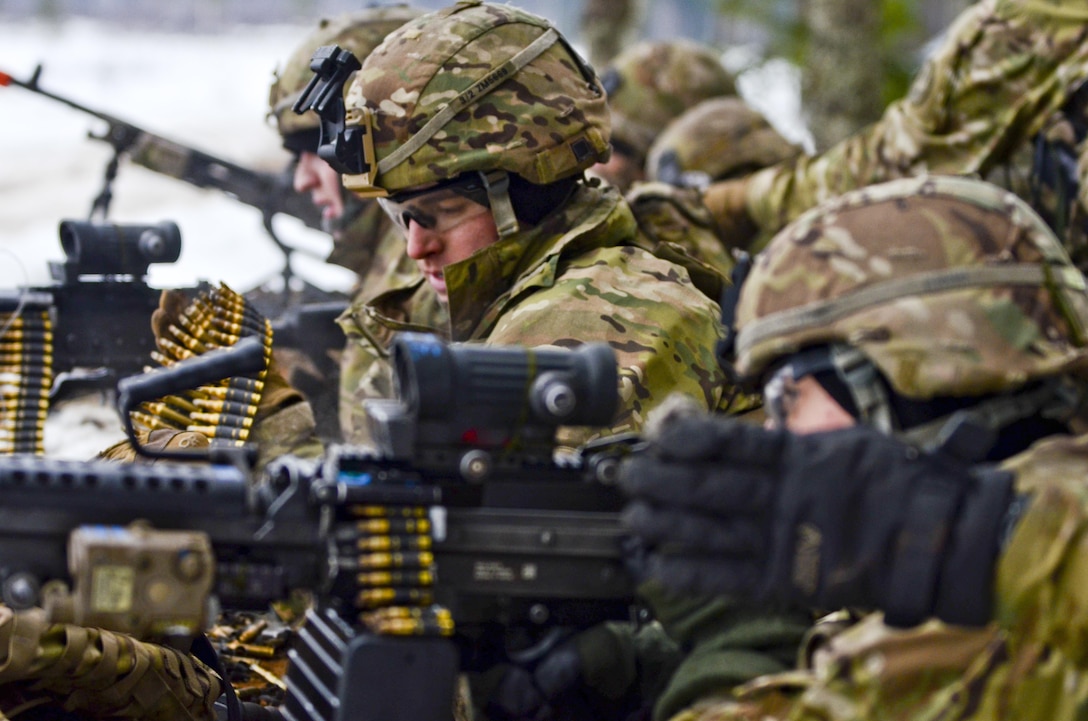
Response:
[[269, 5, 422, 138]]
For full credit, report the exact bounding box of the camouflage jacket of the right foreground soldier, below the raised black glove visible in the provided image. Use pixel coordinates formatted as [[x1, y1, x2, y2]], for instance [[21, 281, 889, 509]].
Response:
[[673, 426, 1088, 721]]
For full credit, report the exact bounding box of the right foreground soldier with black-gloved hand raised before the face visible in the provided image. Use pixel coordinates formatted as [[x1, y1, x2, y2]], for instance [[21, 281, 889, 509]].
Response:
[[621, 176, 1088, 720]]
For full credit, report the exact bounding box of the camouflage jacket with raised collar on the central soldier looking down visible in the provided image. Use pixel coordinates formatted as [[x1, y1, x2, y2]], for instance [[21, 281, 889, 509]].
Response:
[[342, 180, 726, 446]]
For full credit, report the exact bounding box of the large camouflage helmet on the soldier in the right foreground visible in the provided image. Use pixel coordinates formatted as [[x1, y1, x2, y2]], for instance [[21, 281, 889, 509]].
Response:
[[734, 176, 1088, 400]]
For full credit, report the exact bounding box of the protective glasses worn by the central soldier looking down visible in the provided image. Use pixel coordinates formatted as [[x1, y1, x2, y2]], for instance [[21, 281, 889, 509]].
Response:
[[378, 175, 491, 234]]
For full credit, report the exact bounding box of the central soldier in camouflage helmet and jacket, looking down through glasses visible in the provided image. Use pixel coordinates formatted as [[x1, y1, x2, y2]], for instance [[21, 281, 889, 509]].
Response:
[[335, 2, 725, 446]]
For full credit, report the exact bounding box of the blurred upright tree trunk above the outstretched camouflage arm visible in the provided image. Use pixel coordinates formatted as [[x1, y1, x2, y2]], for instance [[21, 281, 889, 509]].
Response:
[[801, 0, 883, 151]]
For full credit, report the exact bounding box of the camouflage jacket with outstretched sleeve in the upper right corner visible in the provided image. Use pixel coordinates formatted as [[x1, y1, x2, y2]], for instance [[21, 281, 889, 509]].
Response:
[[746, 0, 1088, 260]]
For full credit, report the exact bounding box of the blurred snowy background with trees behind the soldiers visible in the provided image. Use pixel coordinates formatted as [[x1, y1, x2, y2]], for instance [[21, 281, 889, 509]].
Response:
[[0, 0, 967, 290]]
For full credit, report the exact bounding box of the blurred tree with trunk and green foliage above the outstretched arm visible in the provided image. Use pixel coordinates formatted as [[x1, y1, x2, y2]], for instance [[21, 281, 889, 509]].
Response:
[[719, 0, 931, 150]]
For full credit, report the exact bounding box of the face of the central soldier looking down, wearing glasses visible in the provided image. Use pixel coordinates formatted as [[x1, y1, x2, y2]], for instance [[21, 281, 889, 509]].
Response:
[[380, 189, 498, 302]]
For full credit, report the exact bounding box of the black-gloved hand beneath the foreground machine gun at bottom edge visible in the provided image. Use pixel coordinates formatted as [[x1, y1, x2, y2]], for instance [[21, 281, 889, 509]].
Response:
[[472, 623, 642, 721]]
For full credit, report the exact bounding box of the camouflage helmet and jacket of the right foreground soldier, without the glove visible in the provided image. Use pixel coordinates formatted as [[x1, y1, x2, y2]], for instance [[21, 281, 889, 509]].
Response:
[[673, 177, 1088, 721]]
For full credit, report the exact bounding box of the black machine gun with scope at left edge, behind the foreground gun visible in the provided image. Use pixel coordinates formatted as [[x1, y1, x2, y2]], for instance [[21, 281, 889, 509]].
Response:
[[0, 220, 343, 445]]
